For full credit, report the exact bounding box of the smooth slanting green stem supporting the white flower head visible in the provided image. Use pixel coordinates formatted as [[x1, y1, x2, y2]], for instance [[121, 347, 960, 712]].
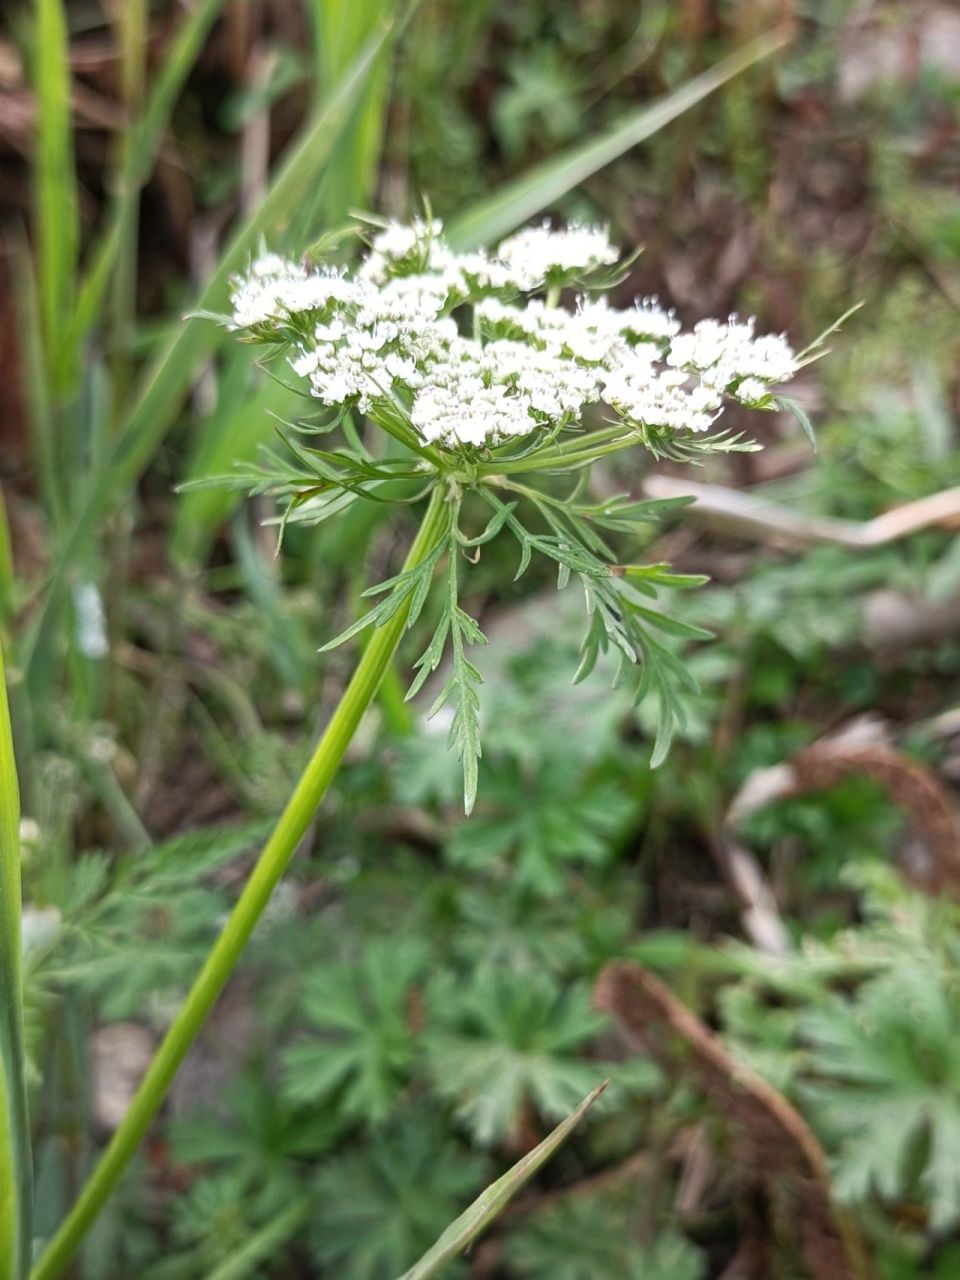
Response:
[[31, 486, 449, 1280]]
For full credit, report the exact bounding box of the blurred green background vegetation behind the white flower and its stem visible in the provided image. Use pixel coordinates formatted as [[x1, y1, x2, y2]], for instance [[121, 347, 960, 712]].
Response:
[[0, 0, 960, 1280]]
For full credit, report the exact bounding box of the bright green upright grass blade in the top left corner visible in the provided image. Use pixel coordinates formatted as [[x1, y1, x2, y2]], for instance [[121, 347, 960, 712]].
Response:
[[33, 0, 79, 389]]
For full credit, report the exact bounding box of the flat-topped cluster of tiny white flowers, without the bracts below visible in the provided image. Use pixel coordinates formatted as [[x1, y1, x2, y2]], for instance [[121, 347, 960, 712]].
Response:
[[230, 220, 796, 451]]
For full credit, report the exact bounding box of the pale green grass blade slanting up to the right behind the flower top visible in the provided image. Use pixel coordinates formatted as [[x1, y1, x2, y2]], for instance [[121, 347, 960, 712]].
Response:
[[447, 31, 790, 250]]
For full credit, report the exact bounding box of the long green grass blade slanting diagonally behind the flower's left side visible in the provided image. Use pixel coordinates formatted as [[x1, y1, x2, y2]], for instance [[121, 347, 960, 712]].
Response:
[[26, 26, 389, 681]]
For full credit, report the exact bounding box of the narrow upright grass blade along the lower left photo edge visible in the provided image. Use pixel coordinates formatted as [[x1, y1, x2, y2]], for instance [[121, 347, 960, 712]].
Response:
[[0, 640, 32, 1280]]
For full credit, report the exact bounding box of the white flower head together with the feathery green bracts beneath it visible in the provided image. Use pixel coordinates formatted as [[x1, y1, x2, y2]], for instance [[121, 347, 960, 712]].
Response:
[[209, 219, 800, 812]]
